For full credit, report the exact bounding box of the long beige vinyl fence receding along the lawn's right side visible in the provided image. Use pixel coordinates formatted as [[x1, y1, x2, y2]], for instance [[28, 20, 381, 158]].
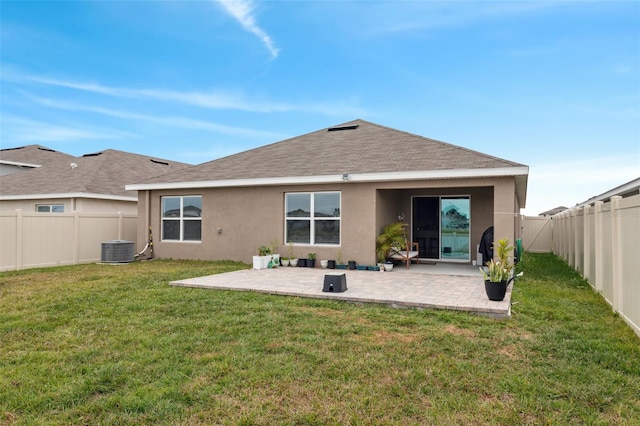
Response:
[[551, 195, 640, 336]]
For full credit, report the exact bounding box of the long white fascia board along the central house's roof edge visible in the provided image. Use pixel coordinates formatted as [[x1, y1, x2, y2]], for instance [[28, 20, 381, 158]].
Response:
[[125, 166, 529, 191]]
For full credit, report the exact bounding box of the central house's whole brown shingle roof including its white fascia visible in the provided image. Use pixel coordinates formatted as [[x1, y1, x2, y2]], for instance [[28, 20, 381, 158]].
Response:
[[127, 120, 529, 206]]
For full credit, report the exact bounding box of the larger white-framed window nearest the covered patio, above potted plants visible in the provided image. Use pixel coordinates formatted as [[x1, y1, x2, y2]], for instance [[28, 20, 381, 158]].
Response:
[[285, 192, 340, 245]]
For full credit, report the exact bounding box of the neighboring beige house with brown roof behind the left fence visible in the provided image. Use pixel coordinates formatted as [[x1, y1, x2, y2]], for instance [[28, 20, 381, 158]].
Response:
[[0, 145, 190, 214]]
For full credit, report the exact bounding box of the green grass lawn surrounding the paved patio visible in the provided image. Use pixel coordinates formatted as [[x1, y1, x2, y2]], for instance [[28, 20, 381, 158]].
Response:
[[0, 255, 640, 425]]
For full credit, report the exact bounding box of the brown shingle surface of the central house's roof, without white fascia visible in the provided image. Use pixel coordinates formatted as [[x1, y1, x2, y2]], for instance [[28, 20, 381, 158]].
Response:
[[139, 120, 523, 184]]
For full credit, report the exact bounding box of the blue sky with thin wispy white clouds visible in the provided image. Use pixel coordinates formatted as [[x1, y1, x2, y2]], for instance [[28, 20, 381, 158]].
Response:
[[0, 0, 640, 214]]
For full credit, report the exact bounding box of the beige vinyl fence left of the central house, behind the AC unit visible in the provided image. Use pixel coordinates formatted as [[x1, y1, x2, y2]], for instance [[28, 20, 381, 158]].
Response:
[[0, 210, 137, 271]]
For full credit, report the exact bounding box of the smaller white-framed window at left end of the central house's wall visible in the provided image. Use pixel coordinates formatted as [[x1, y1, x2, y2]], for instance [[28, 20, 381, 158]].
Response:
[[162, 195, 202, 241]]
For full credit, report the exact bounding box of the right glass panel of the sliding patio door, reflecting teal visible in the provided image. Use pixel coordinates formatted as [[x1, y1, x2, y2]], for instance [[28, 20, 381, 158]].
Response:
[[440, 197, 470, 261]]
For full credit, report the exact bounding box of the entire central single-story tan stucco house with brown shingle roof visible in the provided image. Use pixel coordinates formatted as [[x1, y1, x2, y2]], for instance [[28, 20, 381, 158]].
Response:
[[126, 120, 529, 264]]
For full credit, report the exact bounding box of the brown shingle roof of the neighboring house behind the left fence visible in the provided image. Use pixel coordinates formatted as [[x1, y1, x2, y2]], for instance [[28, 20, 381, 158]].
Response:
[[0, 145, 189, 201]]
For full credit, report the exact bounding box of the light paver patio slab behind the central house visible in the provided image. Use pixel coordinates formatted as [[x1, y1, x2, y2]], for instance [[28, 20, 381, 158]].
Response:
[[170, 263, 513, 318]]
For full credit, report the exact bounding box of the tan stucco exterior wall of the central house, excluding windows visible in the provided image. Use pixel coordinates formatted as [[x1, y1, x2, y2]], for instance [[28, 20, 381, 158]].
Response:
[[138, 178, 517, 264]]
